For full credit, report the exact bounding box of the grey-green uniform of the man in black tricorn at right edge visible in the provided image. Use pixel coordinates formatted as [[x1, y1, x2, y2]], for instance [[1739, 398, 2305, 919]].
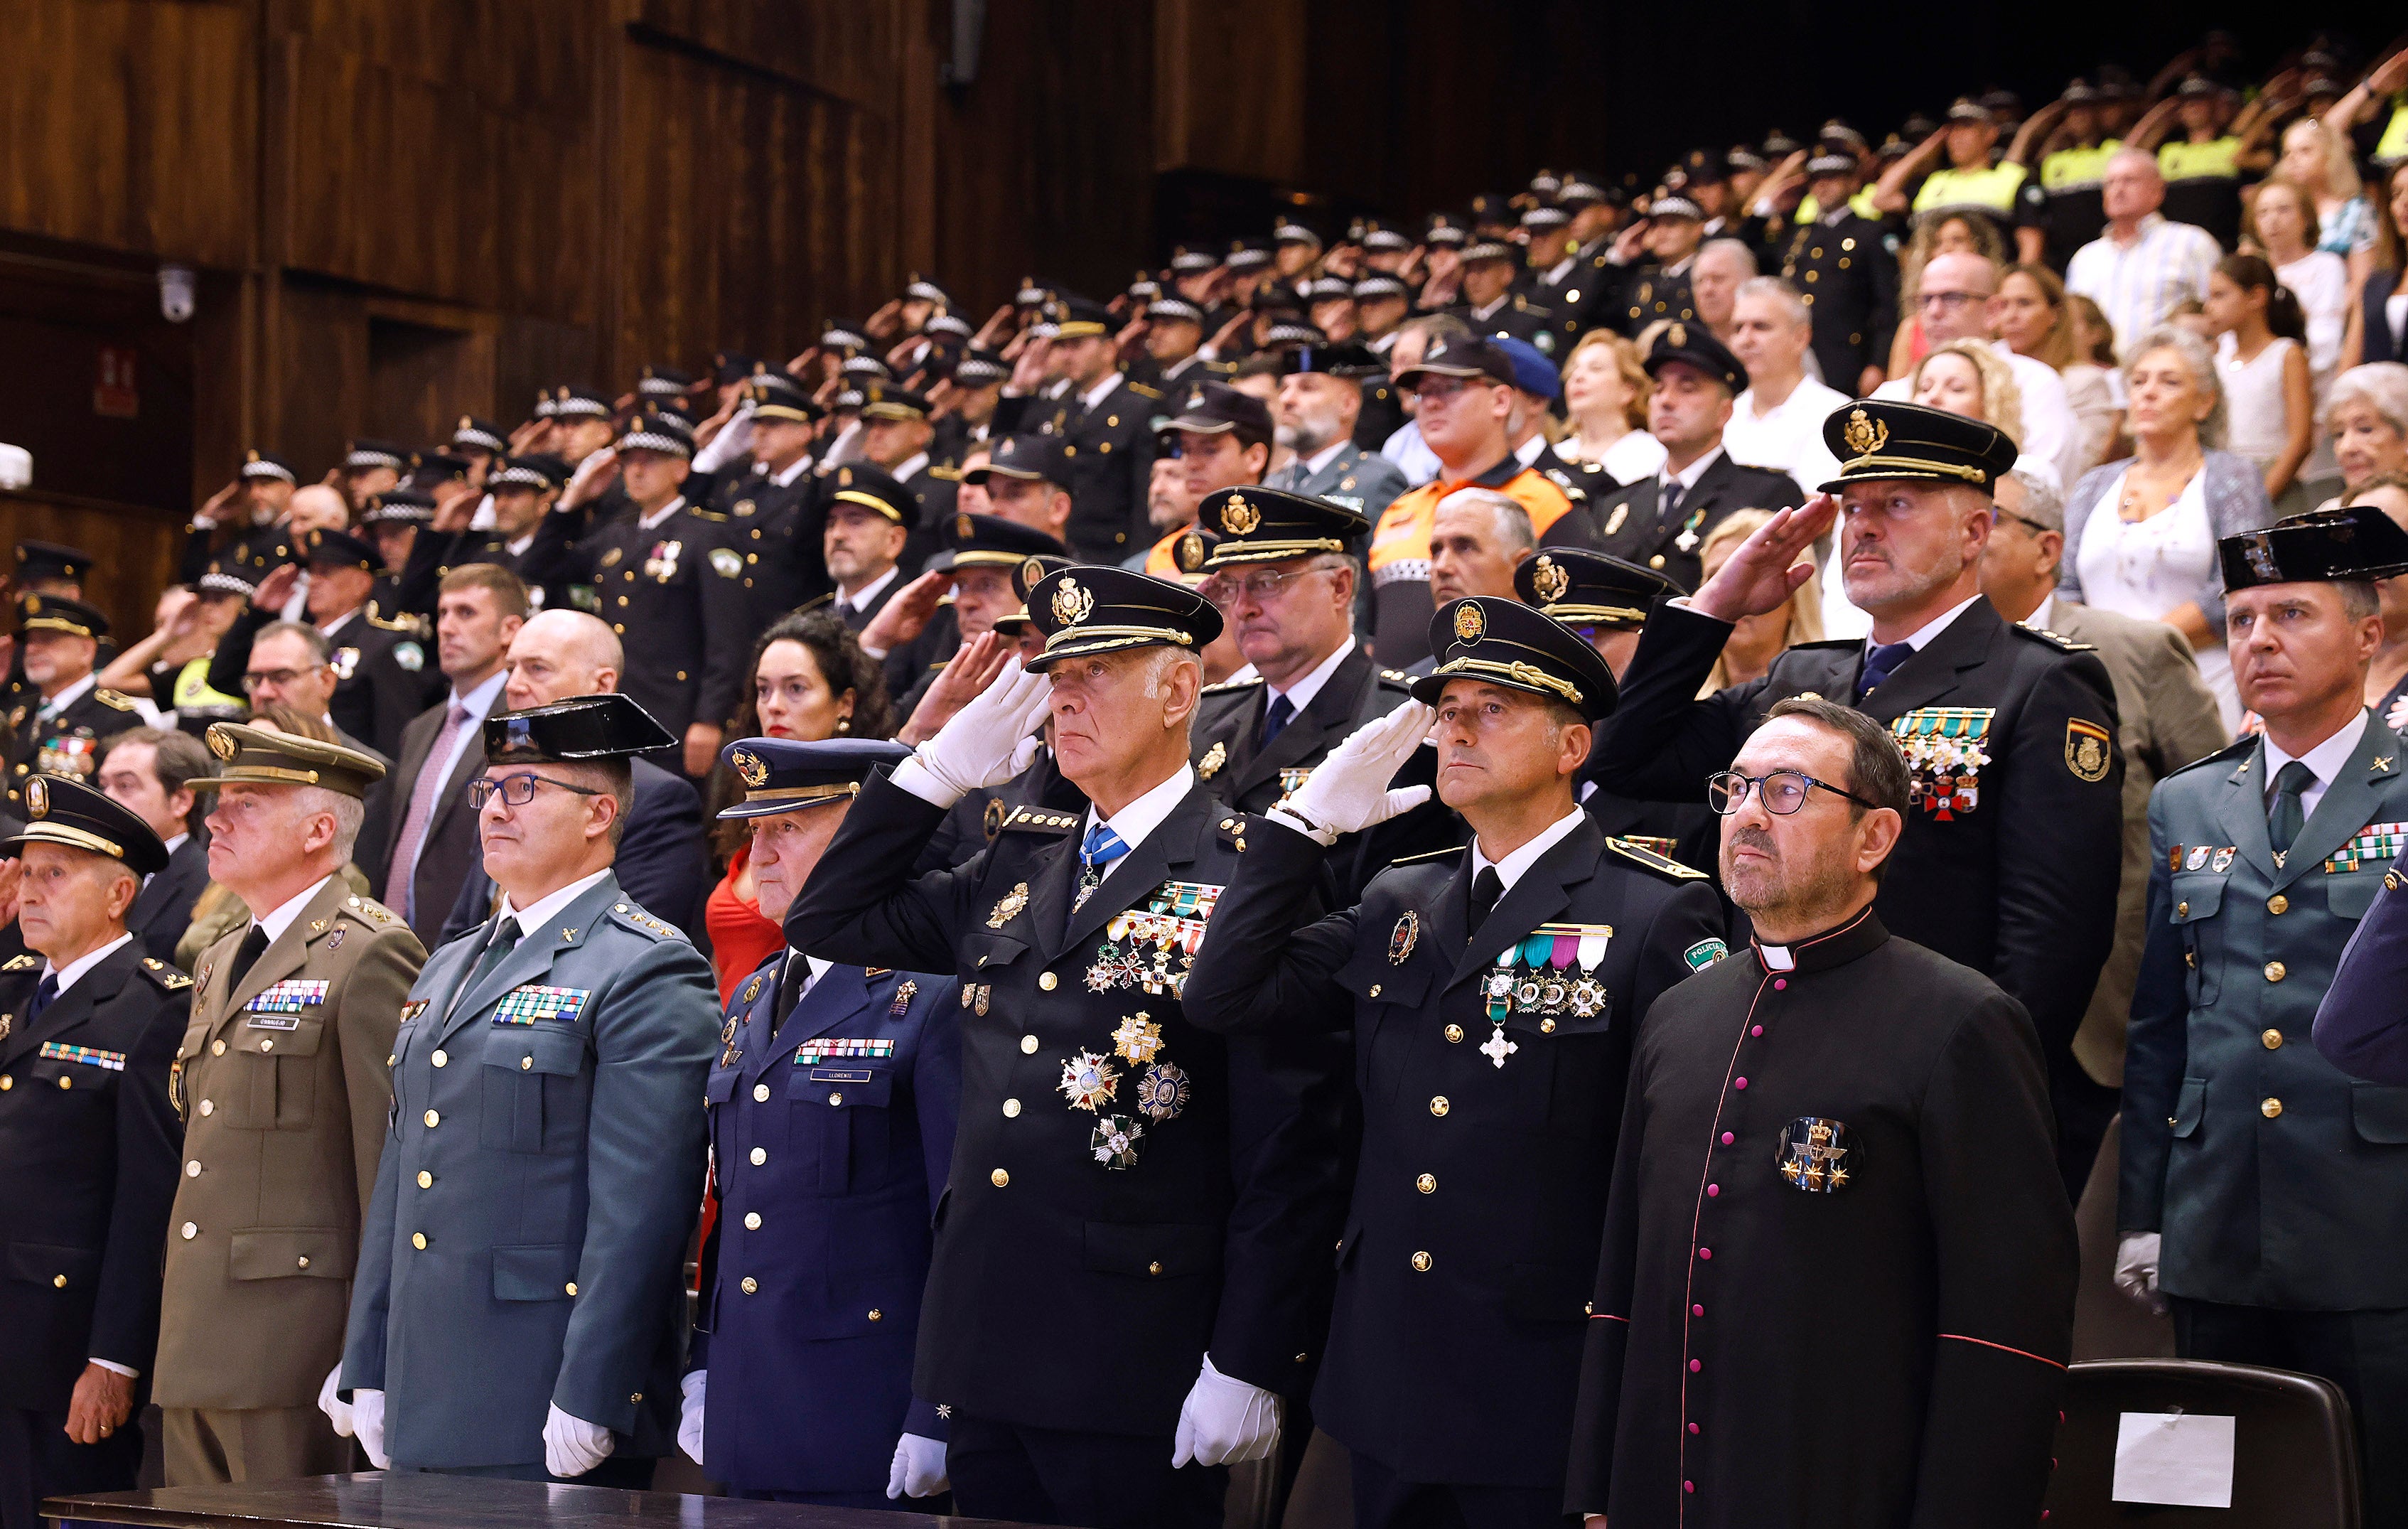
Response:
[[2117, 715, 2408, 1529]]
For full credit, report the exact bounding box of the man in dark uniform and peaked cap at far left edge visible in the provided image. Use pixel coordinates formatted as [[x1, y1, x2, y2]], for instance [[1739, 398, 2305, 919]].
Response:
[[0, 776, 193, 1529]]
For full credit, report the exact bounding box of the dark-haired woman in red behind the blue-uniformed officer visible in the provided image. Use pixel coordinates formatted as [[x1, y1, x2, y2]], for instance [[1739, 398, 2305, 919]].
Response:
[[703, 609, 896, 1004]]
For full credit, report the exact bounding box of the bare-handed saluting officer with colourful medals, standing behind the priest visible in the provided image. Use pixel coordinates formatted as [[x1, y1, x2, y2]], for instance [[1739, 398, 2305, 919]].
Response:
[[1599, 399, 2124, 1199]]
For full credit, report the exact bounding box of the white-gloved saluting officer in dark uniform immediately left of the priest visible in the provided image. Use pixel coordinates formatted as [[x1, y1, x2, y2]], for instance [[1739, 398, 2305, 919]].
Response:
[[1187, 597, 1724, 1529]]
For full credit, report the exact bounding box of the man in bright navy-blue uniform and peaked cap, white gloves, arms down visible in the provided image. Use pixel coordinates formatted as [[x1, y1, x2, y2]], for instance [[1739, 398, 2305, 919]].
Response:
[[677, 737, 961, 1508]]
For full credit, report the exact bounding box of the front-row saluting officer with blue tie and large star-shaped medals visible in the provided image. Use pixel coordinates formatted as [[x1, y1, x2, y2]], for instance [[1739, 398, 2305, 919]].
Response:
[[785, 566, 1341, 1529]]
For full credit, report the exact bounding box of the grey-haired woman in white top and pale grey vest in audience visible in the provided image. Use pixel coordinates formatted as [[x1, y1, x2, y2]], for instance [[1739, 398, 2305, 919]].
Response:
[[2056, 325, 2273, 732]]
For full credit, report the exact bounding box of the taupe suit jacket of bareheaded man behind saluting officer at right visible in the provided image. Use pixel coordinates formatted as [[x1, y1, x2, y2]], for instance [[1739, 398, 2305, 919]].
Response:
[[2047, 599, 2232, 1088]]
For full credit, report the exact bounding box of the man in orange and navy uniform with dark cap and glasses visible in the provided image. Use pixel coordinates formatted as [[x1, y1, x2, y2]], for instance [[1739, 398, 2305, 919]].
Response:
[[1370, 328, 1572, 670]]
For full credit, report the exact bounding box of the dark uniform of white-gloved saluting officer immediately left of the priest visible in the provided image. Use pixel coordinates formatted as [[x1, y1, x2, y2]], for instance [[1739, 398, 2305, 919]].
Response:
[[1187, 816, 1724, 1527]]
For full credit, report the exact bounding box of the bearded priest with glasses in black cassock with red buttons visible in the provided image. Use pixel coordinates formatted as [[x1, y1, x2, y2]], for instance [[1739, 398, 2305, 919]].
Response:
[[1563, 696, 2075, 1529]]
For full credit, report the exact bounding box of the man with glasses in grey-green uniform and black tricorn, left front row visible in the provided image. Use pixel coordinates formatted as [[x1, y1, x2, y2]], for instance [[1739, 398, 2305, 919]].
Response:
[[337, 696, 720, 1488]]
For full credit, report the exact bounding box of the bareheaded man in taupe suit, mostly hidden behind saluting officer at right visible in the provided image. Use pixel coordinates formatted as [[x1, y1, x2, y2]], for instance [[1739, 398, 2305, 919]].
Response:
[[1982, 472, 2232, 1358]]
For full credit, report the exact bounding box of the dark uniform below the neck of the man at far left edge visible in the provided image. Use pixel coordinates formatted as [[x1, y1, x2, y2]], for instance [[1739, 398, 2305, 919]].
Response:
[[0, 939, 193, 1529]]
